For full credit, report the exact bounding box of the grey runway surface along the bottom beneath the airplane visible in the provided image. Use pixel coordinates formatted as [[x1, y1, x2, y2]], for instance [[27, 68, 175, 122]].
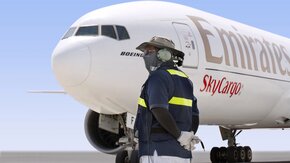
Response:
[[0, 151, 290, 163]]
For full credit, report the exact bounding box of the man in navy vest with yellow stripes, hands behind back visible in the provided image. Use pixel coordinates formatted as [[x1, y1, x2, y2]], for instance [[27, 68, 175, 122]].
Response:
[[135, 36, 199, 163]]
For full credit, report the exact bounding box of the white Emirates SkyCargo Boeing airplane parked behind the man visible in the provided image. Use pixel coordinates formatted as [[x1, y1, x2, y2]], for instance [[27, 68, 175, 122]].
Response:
[[51, 1, 290, 163]]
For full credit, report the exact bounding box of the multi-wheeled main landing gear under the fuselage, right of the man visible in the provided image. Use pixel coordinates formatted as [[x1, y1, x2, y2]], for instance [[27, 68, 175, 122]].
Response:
[[210, 127, 252, 163]]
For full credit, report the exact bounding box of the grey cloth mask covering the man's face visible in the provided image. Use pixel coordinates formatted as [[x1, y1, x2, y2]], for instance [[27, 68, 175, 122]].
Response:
[[143, 52, 162, 73]]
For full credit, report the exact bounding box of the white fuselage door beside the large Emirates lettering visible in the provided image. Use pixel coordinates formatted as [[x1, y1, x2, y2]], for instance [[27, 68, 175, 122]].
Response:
[[173, 22, 198, 68]]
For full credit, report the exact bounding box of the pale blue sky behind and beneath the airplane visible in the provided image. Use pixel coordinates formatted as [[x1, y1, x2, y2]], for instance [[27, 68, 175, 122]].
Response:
[[0, 0, 290, 151]]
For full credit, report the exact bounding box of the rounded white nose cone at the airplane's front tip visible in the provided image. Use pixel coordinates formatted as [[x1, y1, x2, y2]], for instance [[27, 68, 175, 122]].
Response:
[[52, 40, 91, 86]]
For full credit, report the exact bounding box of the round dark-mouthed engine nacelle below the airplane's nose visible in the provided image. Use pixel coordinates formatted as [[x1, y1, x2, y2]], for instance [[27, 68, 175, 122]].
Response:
[[85, 110, 125, 154]]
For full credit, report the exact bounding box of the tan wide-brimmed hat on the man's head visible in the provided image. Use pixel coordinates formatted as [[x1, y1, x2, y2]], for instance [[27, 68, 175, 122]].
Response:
[[136, 36, 184, 58]]
